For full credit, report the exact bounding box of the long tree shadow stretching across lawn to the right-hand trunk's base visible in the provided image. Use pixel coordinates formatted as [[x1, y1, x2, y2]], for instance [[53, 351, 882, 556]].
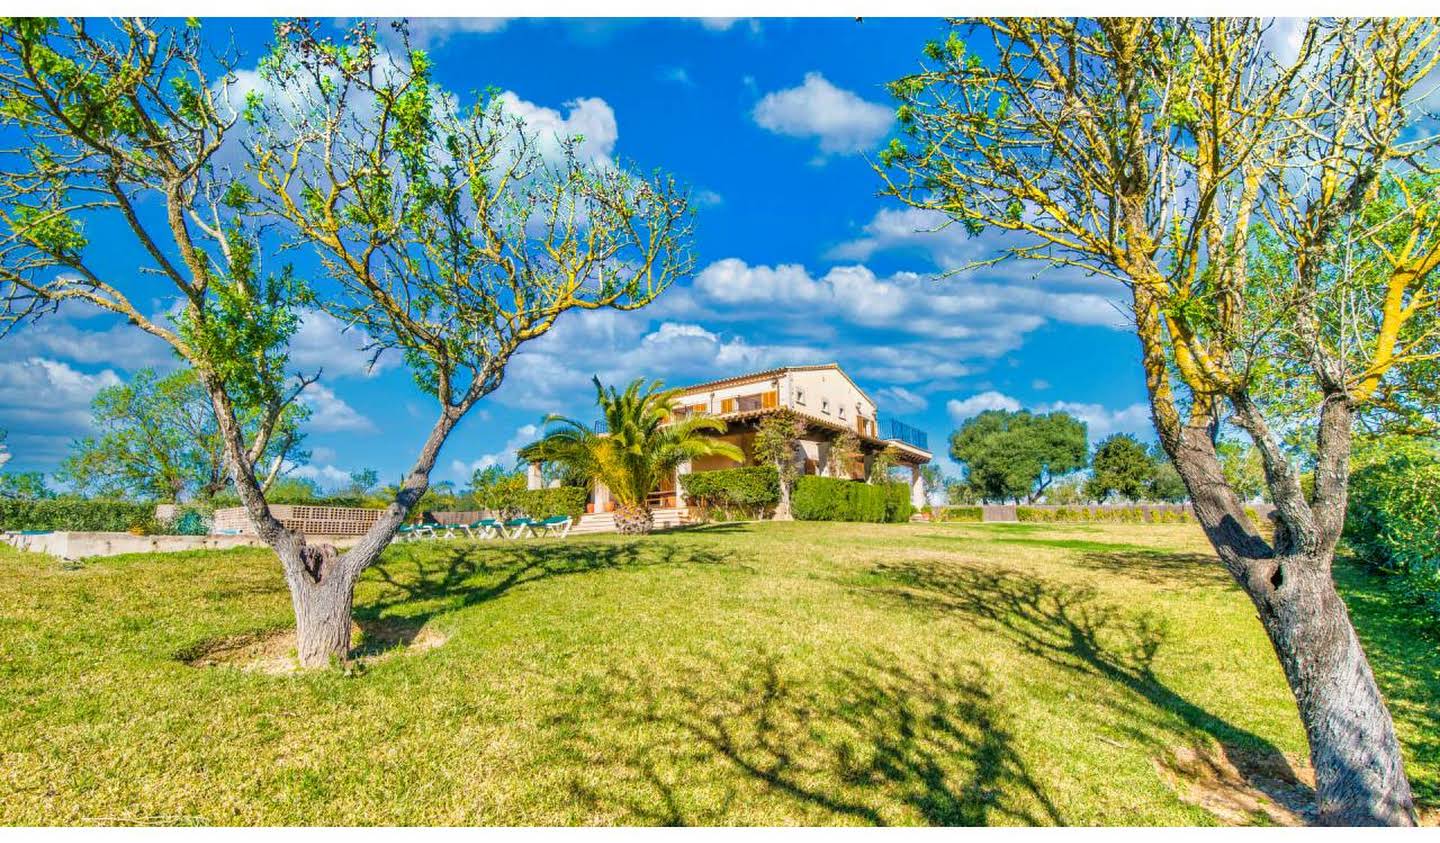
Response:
[[871, 563, 1315, 820]]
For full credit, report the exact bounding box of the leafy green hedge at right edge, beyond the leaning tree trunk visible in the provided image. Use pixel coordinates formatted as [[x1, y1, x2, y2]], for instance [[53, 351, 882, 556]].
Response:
[[1345, 448, 1440, 621]]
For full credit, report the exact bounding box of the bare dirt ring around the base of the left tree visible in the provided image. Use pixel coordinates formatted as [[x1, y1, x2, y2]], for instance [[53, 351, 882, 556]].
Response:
[[177, 618, 448, 676]]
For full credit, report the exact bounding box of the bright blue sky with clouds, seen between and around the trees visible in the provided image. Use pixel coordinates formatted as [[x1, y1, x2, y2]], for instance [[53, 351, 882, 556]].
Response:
[[0, 19, 1152, 486]]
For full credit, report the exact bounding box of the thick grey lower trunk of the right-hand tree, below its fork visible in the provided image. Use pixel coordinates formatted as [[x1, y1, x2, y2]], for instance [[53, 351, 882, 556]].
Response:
[[1247, 556, 1416, 826]]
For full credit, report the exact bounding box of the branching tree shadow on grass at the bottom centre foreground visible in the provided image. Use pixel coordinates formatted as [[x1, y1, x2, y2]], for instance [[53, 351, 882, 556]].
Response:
[[570, 653, 1064, 826]]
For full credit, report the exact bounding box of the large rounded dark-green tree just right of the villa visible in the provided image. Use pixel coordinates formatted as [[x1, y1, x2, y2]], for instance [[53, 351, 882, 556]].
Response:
[[950, 409, 1090, 501]]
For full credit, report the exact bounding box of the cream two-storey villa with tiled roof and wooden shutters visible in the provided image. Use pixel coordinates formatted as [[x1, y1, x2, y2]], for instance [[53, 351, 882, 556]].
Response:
[[528, 363, 932, 519]]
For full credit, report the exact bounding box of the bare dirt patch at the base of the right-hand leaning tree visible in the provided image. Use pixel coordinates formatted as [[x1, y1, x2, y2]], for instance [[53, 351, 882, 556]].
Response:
[[1155, 745, 1315, 826]]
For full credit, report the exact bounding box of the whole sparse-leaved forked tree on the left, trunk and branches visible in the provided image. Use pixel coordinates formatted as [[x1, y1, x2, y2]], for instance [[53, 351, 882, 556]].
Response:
[[0, 19, 691, 666]]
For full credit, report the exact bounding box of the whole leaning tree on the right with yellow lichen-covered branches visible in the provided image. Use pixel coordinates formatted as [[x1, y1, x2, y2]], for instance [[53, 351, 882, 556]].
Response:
[[881, 19, 1440, 824]]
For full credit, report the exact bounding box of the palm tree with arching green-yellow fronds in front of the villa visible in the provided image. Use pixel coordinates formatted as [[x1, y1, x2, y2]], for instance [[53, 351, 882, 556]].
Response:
[[520, 378, 744, 533]]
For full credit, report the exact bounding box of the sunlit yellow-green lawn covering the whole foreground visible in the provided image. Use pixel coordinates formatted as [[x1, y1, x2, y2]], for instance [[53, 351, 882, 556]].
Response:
[[0, 523, 1440, 824]]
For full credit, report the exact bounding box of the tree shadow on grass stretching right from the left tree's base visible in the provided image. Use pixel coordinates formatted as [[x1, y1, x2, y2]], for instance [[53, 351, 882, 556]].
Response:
[[353, 540, 737, 656]]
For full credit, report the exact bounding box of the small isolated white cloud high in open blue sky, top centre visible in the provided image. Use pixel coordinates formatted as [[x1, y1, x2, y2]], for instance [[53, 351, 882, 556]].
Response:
[[752, 72, 894, 154]]
